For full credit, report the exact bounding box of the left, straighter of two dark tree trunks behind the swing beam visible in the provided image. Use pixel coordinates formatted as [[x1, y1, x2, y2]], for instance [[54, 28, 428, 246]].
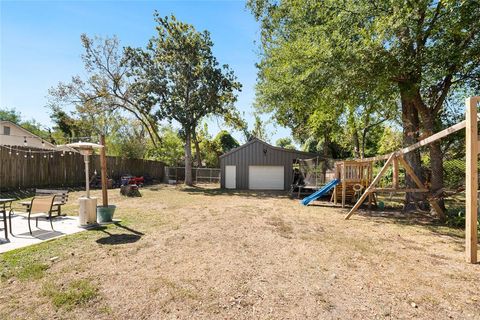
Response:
[[400, 86, 426, 210]]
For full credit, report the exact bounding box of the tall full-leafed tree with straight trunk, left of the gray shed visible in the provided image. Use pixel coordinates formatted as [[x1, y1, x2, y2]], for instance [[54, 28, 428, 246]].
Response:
[[125, 12, 241, 185]]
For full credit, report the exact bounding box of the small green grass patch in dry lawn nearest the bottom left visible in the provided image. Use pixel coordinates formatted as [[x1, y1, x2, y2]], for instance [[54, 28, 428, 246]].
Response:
[[42, 279, 98, 310]]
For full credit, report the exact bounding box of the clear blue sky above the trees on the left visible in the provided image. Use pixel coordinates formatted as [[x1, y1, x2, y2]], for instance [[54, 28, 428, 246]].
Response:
[[0, 0, 290, 142]]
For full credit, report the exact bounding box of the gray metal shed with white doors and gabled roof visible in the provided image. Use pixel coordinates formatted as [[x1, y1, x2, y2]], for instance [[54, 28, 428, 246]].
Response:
[[220, 138, 317, 190]]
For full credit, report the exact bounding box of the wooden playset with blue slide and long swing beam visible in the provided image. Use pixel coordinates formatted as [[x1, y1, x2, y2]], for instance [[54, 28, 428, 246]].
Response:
[[302, 96, 480, 263]]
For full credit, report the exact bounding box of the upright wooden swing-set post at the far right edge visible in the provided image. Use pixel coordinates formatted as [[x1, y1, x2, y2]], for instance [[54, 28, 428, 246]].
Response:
[[465, 97, 479, 263]]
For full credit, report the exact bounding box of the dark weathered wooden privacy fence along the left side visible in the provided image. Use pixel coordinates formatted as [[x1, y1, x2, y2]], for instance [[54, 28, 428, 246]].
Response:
[[0, 146, 165, 191]]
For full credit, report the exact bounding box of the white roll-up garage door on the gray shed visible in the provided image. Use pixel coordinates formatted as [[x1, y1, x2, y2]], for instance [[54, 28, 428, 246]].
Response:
[[248, 166, 285, 190]]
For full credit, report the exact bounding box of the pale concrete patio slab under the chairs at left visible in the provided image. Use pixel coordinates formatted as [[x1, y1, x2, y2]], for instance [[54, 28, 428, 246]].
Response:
[[0, 215, 85, 253]]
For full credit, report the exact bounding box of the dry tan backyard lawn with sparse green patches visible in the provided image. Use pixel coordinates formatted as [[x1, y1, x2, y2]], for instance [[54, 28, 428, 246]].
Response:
[[0, 185, 480, 320]]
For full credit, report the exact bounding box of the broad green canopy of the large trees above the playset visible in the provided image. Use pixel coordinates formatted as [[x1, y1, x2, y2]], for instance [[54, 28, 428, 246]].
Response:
[[248, 0, 480, 162]]
